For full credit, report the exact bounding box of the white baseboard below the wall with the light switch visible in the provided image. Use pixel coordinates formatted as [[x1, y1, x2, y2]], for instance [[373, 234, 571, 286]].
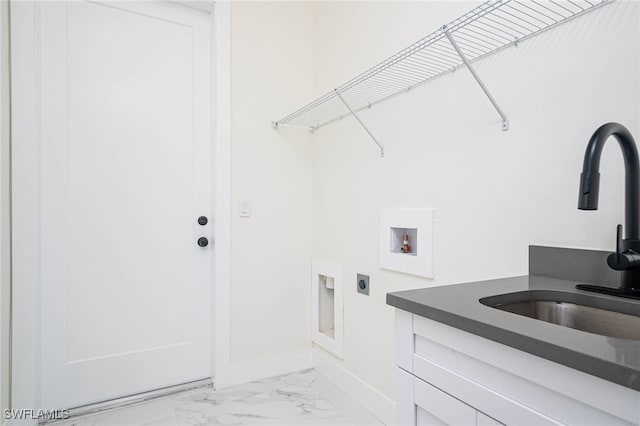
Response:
[[214, 349, 312, 389]]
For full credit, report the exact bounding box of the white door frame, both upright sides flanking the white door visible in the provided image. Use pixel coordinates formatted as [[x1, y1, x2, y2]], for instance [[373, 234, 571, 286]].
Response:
[[11, 0, 231, 412]]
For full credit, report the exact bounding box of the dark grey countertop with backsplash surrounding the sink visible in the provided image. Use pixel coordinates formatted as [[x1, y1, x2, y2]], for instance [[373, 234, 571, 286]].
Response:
[[387, 247, 640, 391]]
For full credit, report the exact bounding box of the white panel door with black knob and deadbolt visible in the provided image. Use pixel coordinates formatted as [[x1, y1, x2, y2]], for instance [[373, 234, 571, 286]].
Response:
[[33, 1, 213, 408]]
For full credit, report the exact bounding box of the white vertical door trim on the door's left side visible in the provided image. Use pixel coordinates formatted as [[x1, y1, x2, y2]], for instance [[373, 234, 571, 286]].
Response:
[[10, 1, 41, 408]]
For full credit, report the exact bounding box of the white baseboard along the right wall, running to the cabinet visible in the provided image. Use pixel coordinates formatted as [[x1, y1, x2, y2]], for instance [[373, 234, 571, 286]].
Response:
[[312, 348, 396, 425]]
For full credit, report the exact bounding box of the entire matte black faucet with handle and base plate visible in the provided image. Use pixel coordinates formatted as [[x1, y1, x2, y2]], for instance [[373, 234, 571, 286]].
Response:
[[576, 123, 640, 299]]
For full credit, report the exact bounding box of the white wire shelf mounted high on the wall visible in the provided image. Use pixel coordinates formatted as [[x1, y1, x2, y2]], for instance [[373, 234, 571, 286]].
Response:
[[272, 0, 613, 131]]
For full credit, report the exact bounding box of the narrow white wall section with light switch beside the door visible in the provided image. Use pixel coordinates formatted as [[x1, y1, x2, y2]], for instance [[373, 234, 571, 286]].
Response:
[[230, 2, 313, 364]]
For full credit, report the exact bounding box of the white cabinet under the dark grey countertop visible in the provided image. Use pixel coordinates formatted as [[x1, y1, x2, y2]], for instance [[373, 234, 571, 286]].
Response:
[[395, 310, 640, 426]]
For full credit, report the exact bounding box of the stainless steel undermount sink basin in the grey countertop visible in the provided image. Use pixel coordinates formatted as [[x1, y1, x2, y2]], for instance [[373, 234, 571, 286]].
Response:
[[480, 290, 640, 340]]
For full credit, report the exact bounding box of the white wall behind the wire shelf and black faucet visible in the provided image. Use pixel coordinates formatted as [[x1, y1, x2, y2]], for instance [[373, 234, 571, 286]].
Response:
[[313, 1, 640, 404]]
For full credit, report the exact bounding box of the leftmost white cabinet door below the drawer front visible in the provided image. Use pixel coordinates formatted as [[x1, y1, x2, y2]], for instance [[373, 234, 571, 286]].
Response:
[[413, 378, 476, 426]]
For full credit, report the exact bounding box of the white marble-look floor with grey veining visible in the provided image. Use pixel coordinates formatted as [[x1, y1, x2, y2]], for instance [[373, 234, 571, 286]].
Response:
[[47, 370, 382, 426]]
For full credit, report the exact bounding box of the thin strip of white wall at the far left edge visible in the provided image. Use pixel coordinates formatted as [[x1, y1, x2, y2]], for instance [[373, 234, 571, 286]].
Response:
[[0, 1, 11, 420]]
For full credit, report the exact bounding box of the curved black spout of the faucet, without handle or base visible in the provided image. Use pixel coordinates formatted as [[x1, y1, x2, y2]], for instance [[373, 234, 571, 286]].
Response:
[[578, 123, 640, 240]]
